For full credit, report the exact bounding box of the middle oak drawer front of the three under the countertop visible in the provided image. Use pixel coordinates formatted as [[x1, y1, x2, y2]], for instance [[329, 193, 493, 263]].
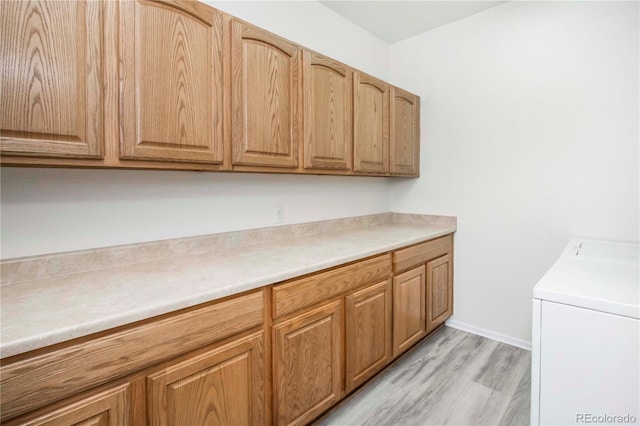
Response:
[[273, 254, 391, 318]]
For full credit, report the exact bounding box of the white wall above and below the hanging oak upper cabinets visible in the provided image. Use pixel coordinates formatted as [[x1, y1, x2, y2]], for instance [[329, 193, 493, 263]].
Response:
[[0, 1, 389, 259]]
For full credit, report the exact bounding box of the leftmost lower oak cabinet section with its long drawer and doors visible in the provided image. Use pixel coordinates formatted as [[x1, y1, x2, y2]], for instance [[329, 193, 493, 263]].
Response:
[[0, 289, 267, 426]]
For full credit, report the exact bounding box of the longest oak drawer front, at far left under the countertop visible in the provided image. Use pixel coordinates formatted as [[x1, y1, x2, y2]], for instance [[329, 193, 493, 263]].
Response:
[[0, 290, 264, 418]]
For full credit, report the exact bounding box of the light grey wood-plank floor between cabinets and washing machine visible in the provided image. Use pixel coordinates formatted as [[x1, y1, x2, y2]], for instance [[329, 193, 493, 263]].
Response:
[[315, 327, 531, 426]]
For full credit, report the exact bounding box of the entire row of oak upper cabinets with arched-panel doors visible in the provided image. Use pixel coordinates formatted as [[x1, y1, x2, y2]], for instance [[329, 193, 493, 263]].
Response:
[[0, 0, 419, 177]]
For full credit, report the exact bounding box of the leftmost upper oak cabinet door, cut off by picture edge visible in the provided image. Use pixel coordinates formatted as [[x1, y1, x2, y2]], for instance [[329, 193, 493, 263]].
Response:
[[0, 1, 104, 158]]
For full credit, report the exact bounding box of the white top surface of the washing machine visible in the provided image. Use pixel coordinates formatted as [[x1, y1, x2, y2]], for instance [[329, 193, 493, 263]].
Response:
[[533, 239, 640, 318]]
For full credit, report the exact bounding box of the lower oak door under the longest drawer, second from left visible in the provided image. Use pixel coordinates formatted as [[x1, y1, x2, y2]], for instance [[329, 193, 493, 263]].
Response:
[[147, 332, 267, 426]]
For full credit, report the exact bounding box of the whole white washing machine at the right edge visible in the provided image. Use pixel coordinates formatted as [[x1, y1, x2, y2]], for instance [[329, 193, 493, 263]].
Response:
[[531, 239, 640, 425]]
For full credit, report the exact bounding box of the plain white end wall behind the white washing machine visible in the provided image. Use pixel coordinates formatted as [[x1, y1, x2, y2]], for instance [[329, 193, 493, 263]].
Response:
[[390, 2, 640, 342]]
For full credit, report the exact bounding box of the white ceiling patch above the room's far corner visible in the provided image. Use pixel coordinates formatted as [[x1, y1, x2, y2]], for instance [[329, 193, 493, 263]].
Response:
[[320, 0, 505, 44]]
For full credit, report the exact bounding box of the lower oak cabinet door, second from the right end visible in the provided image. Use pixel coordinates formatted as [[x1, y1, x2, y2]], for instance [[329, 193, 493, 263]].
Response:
[[393, 265, 426, 358]]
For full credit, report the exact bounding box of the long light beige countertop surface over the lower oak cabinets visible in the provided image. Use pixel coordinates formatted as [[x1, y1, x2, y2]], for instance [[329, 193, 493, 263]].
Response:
[[0, 215, 456, 358]]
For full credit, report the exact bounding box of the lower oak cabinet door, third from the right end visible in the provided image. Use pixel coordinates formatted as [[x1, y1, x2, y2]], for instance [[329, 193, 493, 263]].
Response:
[[345, 280, 391, 392]]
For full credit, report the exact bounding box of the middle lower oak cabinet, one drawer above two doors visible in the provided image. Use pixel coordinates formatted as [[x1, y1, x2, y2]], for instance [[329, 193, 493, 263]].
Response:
[[273, 262, 392, 425]]
